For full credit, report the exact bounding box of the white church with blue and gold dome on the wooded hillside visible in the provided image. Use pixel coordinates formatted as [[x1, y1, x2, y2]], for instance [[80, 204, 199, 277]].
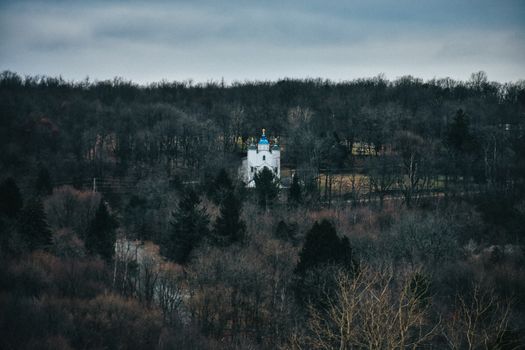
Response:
[[241, 129, 281, 187]]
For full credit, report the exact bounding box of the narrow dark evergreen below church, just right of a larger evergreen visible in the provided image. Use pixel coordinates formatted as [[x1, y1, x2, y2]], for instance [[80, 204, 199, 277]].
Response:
[[213, 191, 246, 245]]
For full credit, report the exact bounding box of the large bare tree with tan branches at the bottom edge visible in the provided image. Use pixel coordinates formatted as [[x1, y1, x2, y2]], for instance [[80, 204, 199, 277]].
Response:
[[291, 267, 439, 350]]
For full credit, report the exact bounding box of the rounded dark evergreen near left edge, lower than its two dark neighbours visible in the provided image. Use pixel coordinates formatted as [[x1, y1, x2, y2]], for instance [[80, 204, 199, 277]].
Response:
[[18, 198, 52, 250]]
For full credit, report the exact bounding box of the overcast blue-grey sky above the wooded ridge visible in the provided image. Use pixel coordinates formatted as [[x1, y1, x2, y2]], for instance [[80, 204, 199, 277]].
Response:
[[0, 0, 525, 83]]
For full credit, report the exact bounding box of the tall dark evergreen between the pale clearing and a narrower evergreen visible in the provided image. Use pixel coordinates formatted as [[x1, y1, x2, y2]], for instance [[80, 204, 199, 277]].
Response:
[[167, 188, 209, 264]]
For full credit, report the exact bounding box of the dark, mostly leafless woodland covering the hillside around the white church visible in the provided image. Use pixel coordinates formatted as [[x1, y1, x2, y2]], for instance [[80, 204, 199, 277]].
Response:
[[0, 71, 525, 349]]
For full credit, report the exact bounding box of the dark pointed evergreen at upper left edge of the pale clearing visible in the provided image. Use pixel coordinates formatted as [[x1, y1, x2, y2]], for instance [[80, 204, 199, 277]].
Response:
[[85, 200, 117, 261]]
